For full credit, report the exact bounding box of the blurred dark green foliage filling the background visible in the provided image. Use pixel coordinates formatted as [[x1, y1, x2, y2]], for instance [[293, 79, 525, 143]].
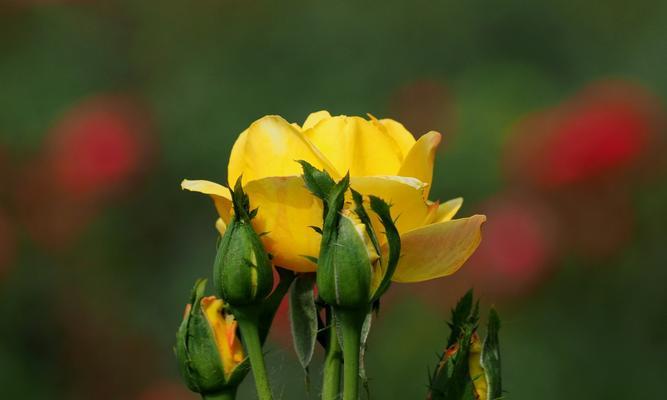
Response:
[[0, 0, 667, 400]]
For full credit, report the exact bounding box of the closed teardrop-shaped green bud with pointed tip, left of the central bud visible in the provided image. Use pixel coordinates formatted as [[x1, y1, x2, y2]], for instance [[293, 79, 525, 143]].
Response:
[[213, 178, 273, 306]]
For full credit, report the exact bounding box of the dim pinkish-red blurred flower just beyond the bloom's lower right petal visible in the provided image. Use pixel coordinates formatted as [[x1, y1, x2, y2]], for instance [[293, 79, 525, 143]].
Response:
[[396, 192, 559, 308]]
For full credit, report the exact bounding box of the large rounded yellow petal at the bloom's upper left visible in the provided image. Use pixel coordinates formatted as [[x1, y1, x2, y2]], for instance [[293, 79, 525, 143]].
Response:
[[228, 115, 340, 185]]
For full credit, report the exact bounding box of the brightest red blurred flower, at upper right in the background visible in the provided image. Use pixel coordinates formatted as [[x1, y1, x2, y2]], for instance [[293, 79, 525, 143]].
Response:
[[508, 81, 663, 188]]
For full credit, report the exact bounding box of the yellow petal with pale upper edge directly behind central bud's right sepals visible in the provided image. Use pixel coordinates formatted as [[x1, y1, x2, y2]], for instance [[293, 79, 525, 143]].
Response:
[[350, 176, 432, 236]]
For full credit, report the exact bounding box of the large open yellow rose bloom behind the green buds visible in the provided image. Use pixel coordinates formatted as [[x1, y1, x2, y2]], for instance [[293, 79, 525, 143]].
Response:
[[182, 111, 486, 282]]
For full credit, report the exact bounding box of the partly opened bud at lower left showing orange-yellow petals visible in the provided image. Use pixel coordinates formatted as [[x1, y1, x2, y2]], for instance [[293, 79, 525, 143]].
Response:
[[176, 280, 249, 394]]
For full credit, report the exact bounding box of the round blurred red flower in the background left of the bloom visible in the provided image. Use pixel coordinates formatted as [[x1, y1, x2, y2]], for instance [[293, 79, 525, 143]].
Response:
[[46, 96, 149, 197]]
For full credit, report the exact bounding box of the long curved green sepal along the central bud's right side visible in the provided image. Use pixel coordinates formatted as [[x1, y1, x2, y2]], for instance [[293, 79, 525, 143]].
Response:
[[369, 196, 401, 302]]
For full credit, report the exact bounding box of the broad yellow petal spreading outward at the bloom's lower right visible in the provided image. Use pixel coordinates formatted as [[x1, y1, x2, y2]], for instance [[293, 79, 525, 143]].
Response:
[[392, 215, 486, 282]]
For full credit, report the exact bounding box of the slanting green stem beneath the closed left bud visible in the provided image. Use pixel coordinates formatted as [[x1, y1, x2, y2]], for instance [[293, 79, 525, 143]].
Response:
[[234, 307, 272, 400]]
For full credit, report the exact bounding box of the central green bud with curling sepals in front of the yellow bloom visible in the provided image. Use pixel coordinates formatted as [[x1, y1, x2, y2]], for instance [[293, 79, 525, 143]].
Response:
[[301, 161, 400, 309]]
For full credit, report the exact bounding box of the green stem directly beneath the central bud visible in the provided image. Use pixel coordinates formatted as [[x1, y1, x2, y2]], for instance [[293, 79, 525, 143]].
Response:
[[336, 309, 366, 400]]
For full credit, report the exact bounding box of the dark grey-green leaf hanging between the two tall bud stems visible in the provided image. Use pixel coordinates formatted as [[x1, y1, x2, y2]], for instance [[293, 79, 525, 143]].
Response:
[[289, 273, 317, 373]]
